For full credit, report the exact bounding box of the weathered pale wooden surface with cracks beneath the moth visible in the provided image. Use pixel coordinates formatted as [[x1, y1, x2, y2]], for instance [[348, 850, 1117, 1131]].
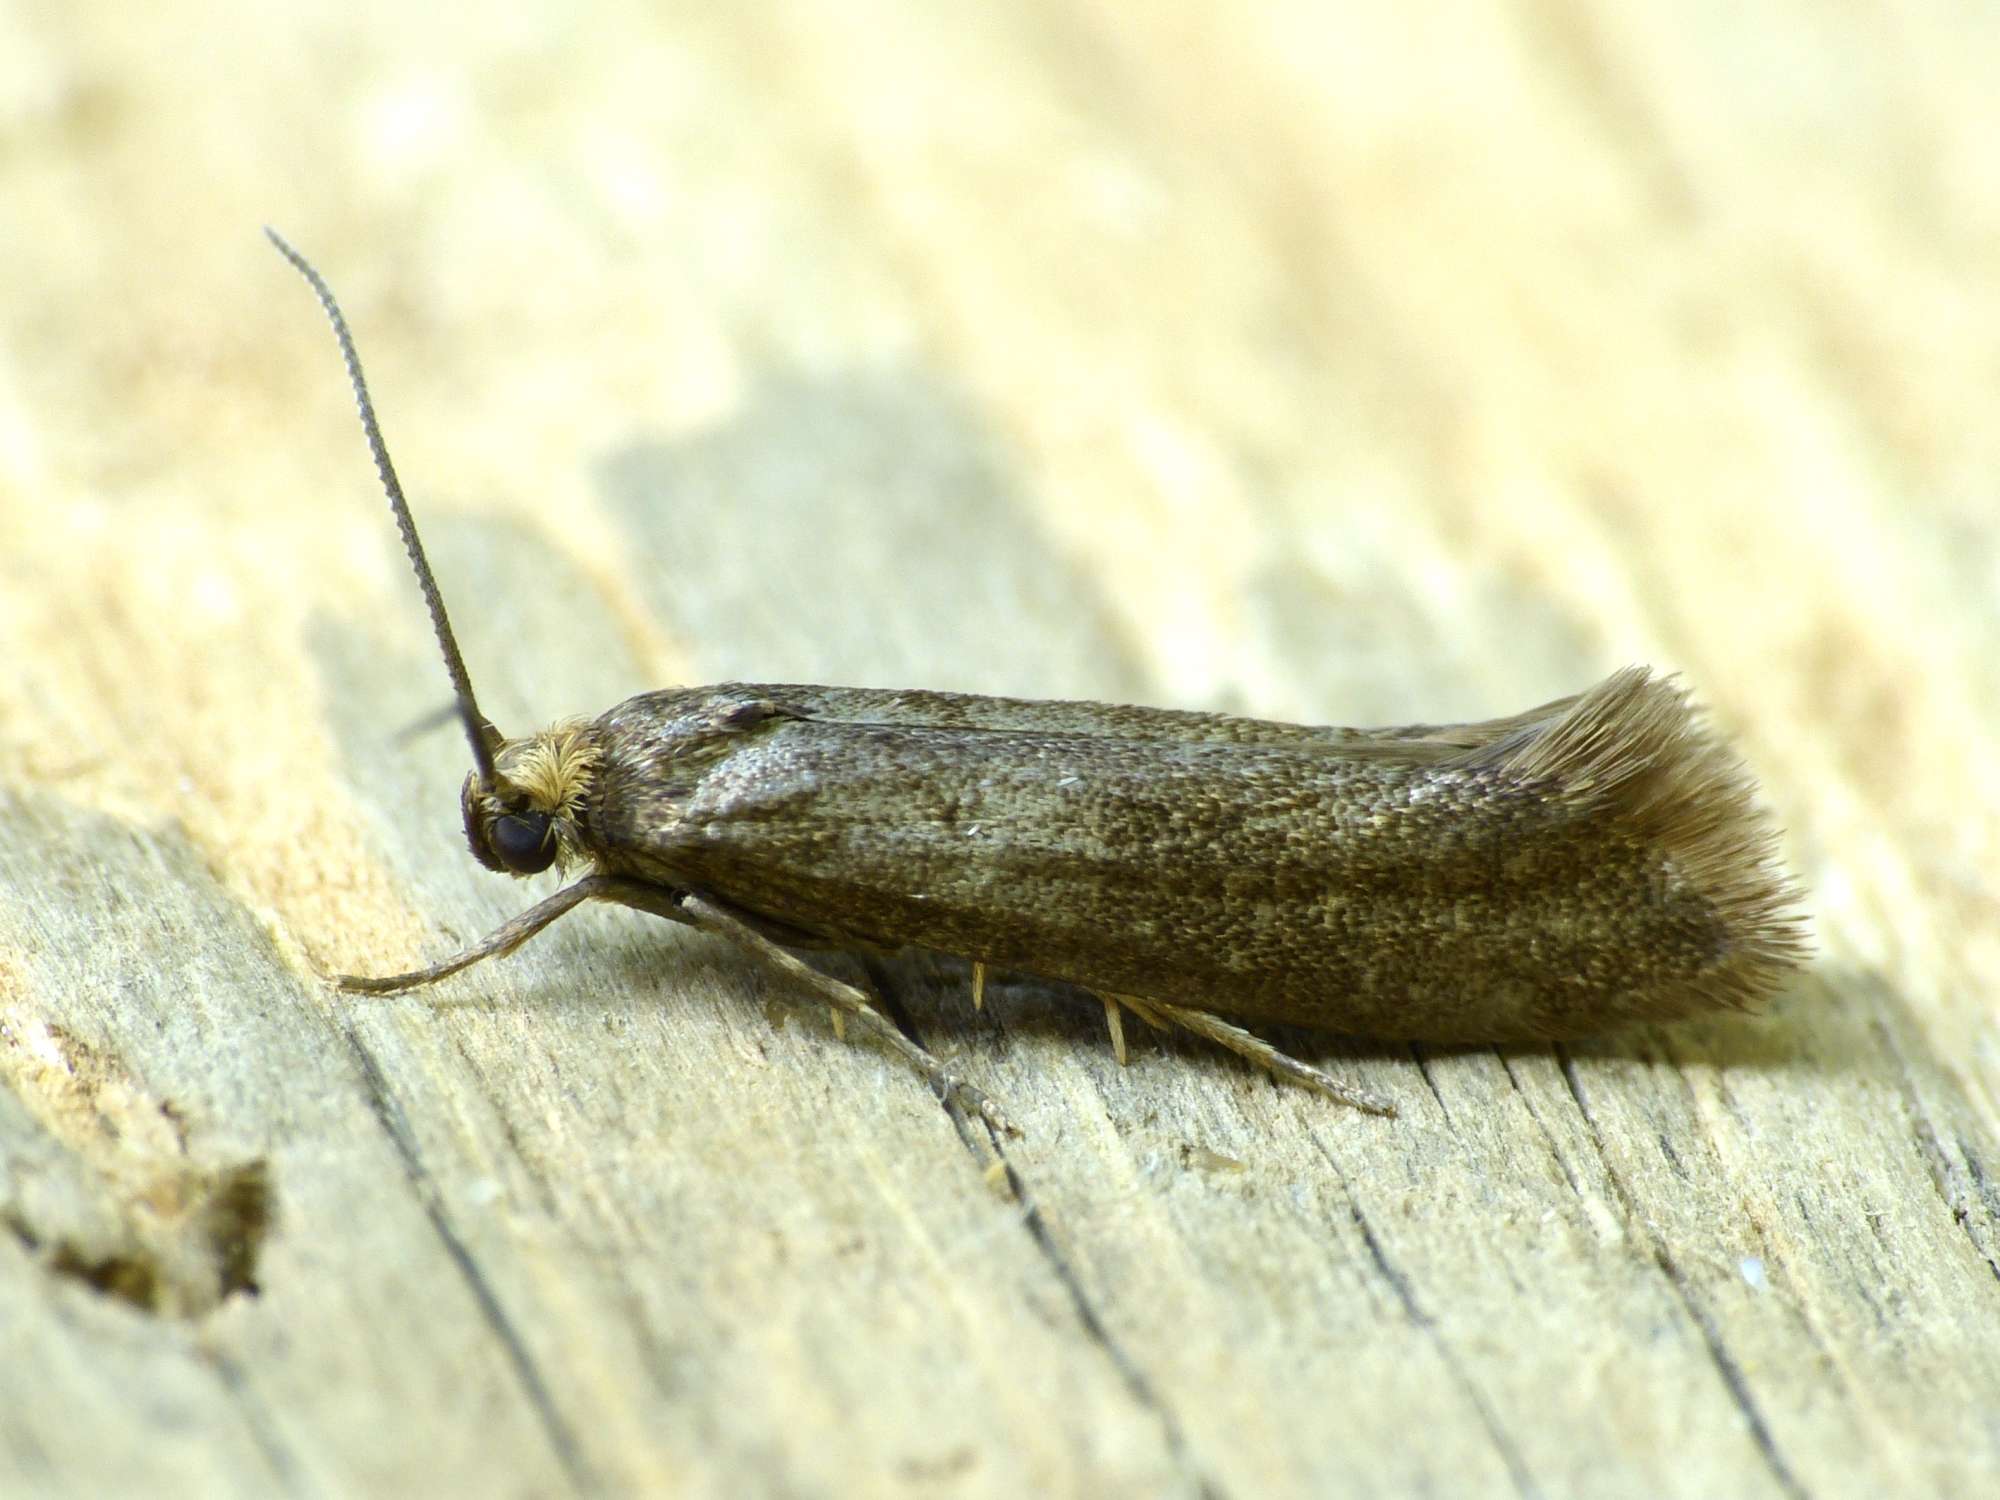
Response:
[[0, 0, 2000, 1496]]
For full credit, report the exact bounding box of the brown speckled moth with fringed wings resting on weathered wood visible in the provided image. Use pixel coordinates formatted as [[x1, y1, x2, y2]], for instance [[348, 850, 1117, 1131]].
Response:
[[266, 230, 1806, 1128]]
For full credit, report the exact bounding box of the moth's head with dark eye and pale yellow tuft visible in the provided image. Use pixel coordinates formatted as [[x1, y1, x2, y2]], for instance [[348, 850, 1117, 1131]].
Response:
[[460, 720, 600, 876]]
